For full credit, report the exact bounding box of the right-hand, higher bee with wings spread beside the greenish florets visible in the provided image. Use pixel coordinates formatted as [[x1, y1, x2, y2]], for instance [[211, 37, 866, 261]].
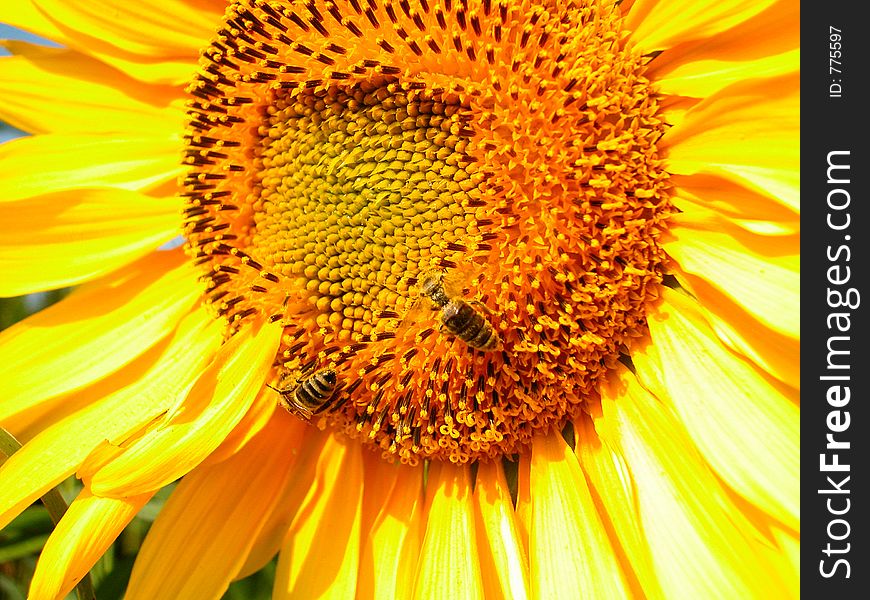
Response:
[[420, 272, 501, 351]]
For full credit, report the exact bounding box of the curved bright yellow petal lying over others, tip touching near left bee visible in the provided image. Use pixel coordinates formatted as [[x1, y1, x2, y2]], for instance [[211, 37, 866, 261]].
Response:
[[81, 324, 282, 496]]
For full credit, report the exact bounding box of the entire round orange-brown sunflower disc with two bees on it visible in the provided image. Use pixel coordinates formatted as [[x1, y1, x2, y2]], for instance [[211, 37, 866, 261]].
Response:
[[185, 0, 672, 462]]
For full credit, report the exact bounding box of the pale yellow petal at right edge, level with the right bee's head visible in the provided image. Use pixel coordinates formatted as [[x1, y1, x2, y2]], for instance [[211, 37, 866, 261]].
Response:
[[663, 207, 800, 339]]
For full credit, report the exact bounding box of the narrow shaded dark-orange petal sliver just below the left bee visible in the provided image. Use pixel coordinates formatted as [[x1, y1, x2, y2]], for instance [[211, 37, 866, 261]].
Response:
[[236, 427, 331, 579]]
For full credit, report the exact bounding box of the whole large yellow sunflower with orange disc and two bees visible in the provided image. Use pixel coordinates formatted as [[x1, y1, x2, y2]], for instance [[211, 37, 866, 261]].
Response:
[[0, 0, 799, 599]]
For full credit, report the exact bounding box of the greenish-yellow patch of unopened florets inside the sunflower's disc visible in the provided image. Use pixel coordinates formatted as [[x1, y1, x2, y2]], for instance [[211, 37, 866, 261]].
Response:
[[252, 78, 479, 341]]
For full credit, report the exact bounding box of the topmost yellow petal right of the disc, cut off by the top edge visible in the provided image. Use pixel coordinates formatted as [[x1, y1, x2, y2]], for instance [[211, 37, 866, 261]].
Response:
[[625, 0, 773, 52]]
